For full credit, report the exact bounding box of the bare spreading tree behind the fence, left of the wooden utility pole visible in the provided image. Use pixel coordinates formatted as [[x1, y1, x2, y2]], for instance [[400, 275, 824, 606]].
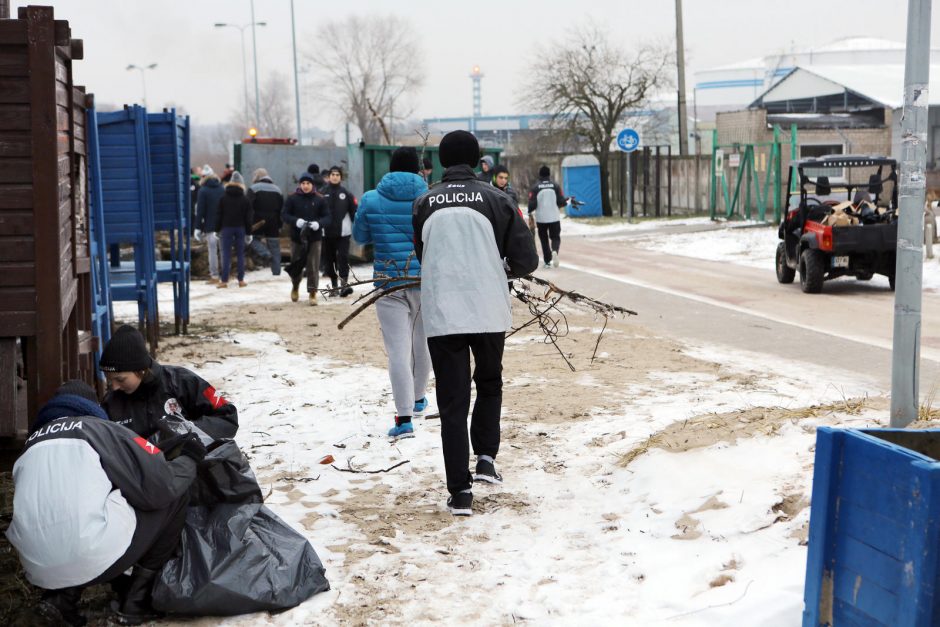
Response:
[[521, 23, 672, 216]]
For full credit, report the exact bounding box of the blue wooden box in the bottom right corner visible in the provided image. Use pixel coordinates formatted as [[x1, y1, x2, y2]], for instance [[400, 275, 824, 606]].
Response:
[[803, 427, 940, 627]]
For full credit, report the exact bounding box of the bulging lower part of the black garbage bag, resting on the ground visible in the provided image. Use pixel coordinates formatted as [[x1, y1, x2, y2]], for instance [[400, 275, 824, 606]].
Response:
[[153, 503, 330, 616]]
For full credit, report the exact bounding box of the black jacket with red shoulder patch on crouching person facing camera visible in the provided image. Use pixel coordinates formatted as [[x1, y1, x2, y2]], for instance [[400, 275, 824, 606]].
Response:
[[101, 362, 238, 439]]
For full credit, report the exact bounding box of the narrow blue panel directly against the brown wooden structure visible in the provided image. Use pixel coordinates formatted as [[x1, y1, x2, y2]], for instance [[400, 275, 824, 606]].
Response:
[[85, 106, 114, 378]]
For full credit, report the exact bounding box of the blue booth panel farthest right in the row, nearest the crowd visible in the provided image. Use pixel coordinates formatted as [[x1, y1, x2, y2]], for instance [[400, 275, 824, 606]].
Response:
[[147, 109, 190, 333]]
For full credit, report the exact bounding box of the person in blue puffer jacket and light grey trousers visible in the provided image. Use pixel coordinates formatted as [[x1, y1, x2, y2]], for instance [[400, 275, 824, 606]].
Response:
[[352, 146, 431, 439]]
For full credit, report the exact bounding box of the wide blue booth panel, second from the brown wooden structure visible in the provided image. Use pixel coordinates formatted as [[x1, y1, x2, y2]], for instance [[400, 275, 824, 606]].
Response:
[[97, 105, 159, 350]]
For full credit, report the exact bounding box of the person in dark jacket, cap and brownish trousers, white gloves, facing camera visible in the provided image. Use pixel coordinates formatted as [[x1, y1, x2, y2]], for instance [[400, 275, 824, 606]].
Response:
[[281, 172, 332, 305]]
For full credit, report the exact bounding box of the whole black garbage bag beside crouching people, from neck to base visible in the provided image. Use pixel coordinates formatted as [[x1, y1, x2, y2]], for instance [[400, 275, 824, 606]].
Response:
[[153, 421, 330, 616]]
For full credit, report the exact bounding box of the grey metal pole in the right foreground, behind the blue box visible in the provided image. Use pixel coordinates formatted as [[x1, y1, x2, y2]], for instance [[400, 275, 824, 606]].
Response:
[[891, 0, 931, 427]]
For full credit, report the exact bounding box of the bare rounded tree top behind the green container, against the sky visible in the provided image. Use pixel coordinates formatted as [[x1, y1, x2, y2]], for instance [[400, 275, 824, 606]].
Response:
[[308, 15, 424, 144]]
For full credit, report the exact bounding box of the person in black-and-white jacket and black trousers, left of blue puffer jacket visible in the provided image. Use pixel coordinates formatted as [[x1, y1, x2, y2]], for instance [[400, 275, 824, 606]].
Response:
[[320, 165, 358, 297]]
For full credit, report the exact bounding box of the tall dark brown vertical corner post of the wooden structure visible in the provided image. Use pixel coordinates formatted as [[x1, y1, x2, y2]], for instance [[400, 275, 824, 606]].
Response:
[[26, 6, 66, 410]]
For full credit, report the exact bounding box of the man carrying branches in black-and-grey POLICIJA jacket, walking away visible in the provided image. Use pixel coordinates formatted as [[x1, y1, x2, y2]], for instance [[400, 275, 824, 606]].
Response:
[[412, 131, 538, 516]]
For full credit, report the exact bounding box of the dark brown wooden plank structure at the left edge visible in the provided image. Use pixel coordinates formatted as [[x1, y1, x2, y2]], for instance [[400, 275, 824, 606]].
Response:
[[0, 6, 94, 438]]
